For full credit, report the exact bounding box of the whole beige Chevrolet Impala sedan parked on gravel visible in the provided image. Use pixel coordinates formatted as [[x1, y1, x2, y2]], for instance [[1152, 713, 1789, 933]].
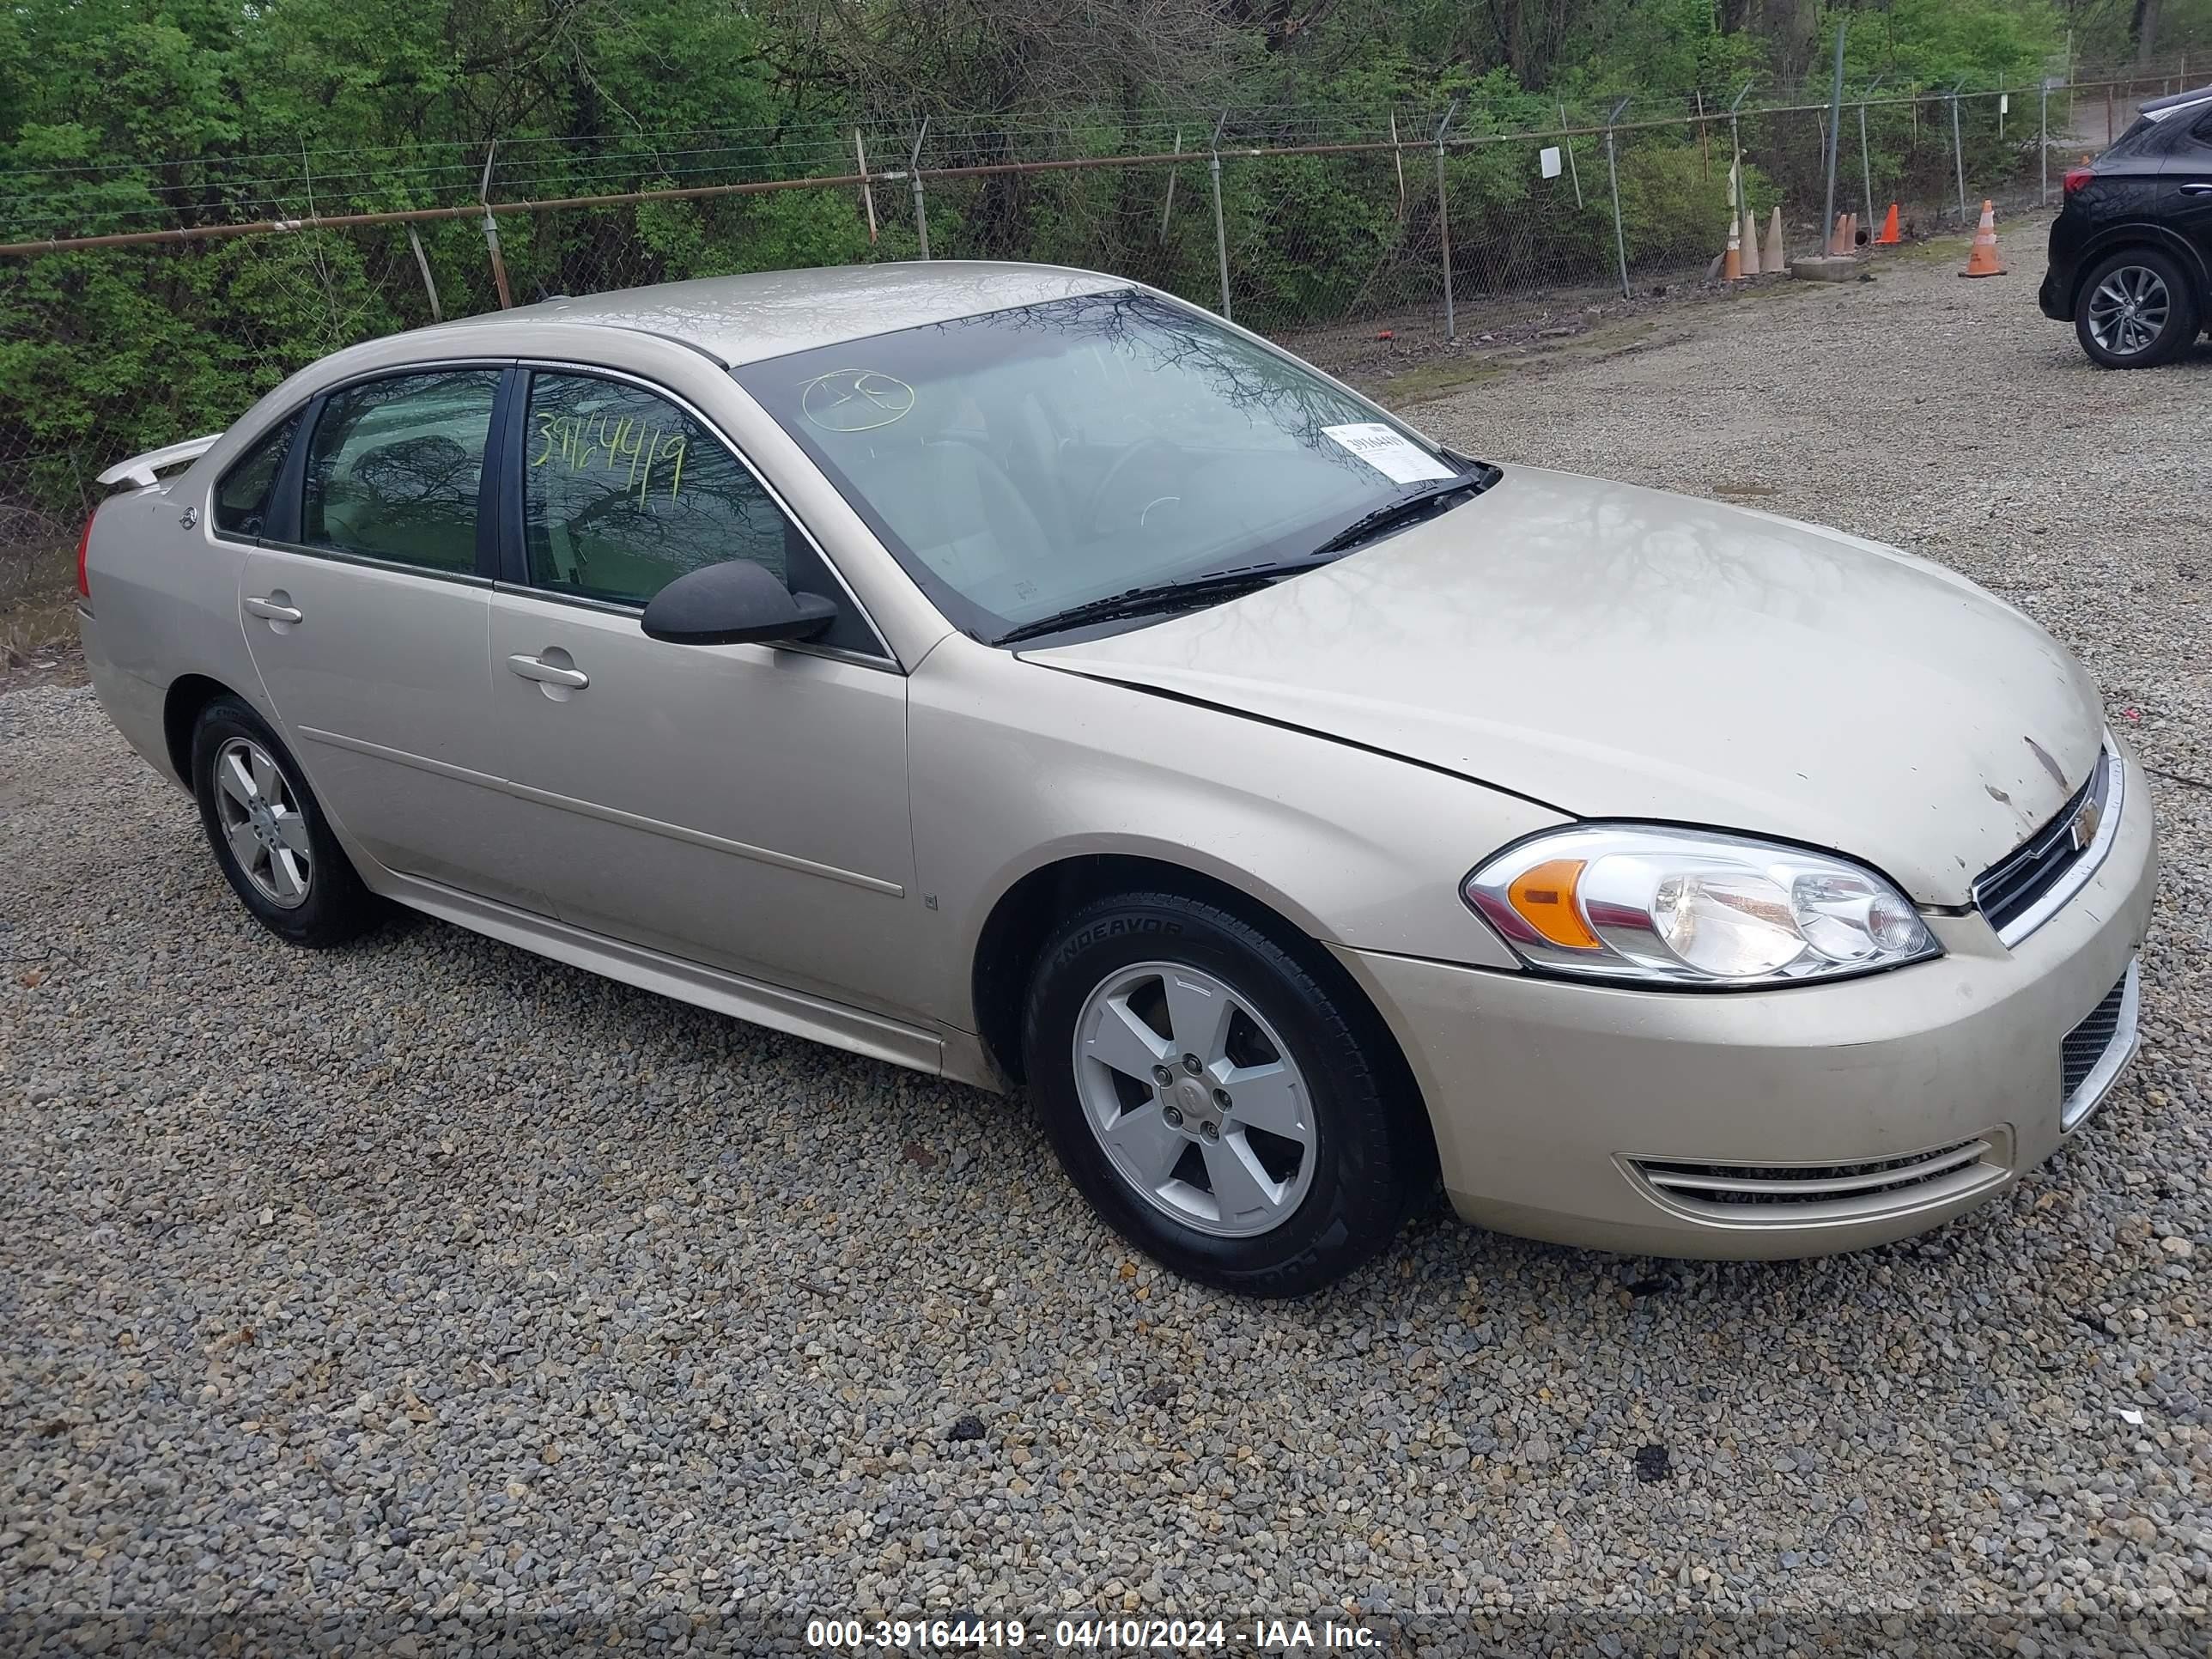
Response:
[[80, 264, 2154, 1294]]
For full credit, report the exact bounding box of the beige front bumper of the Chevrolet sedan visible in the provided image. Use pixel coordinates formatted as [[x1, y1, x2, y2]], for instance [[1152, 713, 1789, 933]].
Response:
[[1338, 757, 2157, 1259]]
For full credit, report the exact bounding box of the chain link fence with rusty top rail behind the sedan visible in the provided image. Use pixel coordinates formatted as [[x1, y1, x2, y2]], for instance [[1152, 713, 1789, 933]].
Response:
[[0, 69, 2188, 653]]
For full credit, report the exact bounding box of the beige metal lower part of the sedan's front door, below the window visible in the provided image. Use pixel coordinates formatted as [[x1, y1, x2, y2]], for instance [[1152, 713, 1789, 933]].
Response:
[[489, 588, 921, 1013]]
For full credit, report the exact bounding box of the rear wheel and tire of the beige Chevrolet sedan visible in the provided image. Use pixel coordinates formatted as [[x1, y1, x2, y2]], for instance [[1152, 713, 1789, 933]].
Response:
[[192, 696, 383, 949]]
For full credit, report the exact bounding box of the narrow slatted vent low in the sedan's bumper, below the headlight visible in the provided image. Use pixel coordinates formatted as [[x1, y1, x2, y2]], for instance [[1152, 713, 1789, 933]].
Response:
[[1628, 1130, 2006, 1224]]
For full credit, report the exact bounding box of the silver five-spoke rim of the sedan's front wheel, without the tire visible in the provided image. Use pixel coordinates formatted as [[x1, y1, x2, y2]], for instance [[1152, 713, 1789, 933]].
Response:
[[1073, 963, 1316, 1239]]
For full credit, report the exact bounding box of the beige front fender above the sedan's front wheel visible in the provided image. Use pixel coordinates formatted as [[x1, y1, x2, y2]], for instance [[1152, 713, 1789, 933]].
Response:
[[909, 637, 1568, 1030]]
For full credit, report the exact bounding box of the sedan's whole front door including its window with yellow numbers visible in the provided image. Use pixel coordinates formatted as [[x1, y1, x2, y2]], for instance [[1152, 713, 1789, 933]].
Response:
[[489, 369, 921, 1013]]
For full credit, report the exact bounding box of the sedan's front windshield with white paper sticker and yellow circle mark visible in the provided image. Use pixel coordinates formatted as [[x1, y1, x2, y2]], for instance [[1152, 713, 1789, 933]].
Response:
[[737, 289, 1460, 639]]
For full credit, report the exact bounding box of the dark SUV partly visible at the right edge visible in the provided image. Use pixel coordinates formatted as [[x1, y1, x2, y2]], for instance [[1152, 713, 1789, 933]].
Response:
[[2037, 86, 2212, 369]]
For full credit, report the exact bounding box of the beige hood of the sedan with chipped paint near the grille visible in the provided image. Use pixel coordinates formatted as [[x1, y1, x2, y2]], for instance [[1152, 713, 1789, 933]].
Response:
[[1024, 467, 2104, 905]]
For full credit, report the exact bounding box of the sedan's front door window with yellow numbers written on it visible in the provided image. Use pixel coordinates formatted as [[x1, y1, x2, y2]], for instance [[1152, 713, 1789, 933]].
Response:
[[522, 374, 803, 604]]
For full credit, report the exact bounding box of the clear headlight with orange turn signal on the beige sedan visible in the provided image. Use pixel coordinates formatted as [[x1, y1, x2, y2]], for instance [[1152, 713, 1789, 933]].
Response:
[[1460, 825, 1942, 984]]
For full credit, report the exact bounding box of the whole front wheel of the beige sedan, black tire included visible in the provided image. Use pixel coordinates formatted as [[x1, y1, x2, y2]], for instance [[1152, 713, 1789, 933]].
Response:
[[1022, 891, 1429, 1297]]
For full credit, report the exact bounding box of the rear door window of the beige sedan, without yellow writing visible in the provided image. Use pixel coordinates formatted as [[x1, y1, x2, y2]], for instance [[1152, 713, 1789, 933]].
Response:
[[301, 369, 500, 575]]
